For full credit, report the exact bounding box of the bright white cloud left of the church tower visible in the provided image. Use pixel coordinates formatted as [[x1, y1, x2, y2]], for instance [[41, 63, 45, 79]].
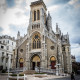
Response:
[[0, 0, 29, 35]]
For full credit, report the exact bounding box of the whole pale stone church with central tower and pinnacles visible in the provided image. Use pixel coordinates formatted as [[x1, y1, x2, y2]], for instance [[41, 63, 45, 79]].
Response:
[[13, 0, 72, 73]]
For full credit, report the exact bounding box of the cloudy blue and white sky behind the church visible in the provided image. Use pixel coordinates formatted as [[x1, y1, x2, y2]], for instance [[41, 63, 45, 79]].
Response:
[[0, 0, 80, 62]]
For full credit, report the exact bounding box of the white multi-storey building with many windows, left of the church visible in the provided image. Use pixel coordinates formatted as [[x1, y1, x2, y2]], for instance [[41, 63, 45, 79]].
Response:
[[0, 35, 16, 70]]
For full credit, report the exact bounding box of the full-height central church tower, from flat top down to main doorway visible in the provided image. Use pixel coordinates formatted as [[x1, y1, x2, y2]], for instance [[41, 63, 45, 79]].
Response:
[[26, 0, 47, 69]]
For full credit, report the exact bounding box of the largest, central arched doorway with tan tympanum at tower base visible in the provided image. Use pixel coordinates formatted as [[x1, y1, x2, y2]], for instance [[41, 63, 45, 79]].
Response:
[[31, 55, 40, 70]]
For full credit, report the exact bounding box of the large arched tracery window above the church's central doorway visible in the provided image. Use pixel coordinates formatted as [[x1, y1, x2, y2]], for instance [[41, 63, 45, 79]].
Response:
[[32, 34, 41, 49]]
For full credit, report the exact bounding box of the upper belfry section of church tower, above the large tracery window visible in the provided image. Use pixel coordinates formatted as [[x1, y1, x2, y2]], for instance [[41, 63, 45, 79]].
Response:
[[28, 0, 47, 33]]
